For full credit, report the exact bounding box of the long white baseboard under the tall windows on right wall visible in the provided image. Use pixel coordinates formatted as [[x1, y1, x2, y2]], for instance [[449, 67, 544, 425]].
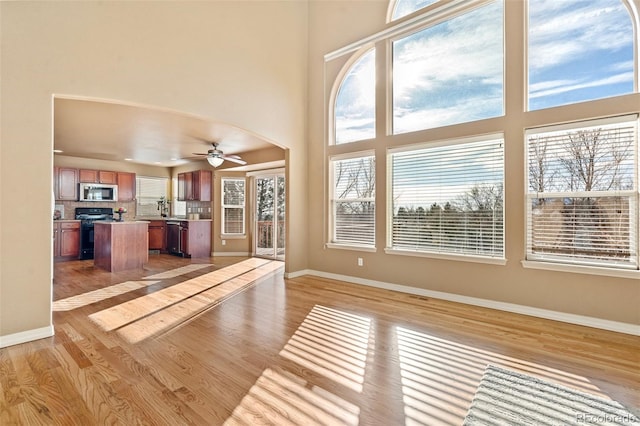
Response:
[[285, 269, 640, 336]]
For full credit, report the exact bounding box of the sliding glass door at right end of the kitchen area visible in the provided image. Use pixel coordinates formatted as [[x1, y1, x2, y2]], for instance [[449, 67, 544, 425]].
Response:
[[253, 171, 285, 260]]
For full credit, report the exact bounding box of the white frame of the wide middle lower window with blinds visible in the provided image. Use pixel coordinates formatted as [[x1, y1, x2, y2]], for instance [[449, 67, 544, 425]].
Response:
[[384, 132, 507, 265]]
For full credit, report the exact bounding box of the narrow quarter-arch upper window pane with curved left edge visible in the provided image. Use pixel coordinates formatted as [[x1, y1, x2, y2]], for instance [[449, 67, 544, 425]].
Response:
[[334, 49, 376, 144]]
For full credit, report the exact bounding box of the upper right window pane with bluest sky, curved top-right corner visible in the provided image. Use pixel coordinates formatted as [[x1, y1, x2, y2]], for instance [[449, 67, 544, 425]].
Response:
[[528, 0, 637, 110]]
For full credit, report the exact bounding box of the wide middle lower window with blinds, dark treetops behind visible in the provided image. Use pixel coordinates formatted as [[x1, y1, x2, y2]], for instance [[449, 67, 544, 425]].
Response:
[[387, 135, 504, 259]]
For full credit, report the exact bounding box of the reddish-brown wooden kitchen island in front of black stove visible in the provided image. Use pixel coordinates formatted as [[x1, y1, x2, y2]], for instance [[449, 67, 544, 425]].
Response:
[[93, 221, 149, 272]]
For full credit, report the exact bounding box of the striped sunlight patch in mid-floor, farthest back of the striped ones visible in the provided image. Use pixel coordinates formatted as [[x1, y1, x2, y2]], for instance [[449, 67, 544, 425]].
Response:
[[280, 305, 373, 392]]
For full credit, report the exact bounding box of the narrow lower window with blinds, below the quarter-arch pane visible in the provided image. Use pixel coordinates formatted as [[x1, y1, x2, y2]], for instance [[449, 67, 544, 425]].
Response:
[[331, 154, 376, 247]]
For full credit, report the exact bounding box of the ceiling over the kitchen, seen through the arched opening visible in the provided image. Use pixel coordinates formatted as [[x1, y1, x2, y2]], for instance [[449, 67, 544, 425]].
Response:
[[54, 98, 274, 167]]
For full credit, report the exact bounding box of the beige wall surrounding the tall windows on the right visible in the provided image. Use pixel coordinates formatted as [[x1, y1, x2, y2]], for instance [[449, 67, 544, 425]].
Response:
[[307, 1, 640, 325]]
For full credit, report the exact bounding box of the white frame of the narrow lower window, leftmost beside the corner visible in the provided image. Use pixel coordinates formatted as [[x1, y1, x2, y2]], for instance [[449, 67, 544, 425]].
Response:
[[325, 150, 377, 252]]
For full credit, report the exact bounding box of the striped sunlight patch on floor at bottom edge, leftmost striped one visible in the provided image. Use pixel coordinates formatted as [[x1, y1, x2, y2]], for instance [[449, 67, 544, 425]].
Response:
[[224, 368, 360, 426]]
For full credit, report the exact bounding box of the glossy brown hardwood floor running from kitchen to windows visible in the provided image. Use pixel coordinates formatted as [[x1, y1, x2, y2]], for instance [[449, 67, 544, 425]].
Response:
[[0, 255, 640, 426]]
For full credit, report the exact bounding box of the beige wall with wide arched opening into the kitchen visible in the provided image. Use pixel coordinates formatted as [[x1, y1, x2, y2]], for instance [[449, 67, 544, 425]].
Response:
[[0, 1, 307, 338]]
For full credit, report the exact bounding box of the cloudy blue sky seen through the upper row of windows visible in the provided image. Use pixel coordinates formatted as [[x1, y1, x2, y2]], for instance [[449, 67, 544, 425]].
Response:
[[336, 0, 634, 143]]
